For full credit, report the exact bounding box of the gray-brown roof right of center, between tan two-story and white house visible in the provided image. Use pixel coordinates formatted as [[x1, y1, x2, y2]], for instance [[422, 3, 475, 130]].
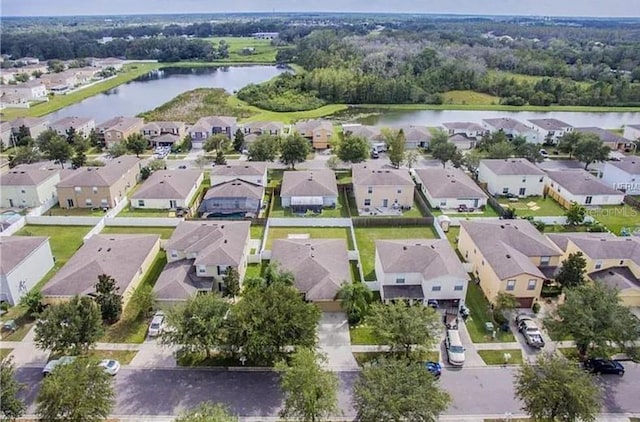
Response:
[[415, 167, 487, 198]]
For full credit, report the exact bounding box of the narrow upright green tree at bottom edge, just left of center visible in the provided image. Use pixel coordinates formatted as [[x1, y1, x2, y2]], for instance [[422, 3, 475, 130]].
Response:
[[276, 347, 338, 422]]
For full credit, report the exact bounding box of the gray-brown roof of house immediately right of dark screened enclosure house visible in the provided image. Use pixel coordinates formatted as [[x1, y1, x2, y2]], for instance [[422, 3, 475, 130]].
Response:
[[280, 170, 338, 197]]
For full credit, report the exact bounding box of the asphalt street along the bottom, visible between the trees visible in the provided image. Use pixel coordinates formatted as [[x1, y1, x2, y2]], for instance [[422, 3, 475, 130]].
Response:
[[17, 363, 640, 417]]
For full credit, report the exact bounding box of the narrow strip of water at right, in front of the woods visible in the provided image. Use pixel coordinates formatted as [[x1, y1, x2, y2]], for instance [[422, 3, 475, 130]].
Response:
[[333, 106, 640, 129]]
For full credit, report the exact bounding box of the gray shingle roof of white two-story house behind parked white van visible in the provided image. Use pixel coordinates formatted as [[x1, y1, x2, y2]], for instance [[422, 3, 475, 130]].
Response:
[[376, 239, 467, 280]]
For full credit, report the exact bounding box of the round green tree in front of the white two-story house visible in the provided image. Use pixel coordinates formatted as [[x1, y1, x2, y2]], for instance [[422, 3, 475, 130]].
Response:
[[365, 302, 442, 358]]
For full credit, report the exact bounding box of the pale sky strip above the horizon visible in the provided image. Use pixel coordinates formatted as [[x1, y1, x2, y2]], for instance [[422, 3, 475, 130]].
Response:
[[0, 0, 640, 17]]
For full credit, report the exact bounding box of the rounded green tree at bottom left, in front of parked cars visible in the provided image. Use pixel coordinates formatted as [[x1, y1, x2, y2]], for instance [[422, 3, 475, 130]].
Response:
[[36, 358, 115, 422]]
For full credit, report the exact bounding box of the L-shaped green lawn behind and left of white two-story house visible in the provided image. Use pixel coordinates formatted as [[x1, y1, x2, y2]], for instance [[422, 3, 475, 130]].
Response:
[[355, 226, 437, 280]]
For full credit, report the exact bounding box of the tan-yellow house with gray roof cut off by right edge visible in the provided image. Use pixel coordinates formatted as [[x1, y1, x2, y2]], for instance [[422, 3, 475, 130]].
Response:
[[548, 233, 640, 306]]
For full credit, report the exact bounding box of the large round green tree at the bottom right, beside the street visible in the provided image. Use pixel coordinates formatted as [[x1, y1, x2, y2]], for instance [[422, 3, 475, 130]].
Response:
[[514, 354, 602, 422]]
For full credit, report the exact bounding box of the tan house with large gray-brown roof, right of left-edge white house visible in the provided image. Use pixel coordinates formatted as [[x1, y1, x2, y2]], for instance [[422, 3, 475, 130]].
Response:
[[42, 234, 160, 306]]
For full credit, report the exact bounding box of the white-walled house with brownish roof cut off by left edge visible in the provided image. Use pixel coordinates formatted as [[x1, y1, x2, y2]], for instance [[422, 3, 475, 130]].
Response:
[[0, 236, 53, 306]]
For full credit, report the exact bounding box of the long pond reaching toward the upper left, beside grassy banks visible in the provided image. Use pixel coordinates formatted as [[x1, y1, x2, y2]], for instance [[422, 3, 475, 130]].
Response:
[[47, 66, 286, 124]]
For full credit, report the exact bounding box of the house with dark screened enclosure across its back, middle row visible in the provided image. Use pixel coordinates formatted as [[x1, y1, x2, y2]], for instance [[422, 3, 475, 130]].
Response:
[[198, 179, 264, 218]]
